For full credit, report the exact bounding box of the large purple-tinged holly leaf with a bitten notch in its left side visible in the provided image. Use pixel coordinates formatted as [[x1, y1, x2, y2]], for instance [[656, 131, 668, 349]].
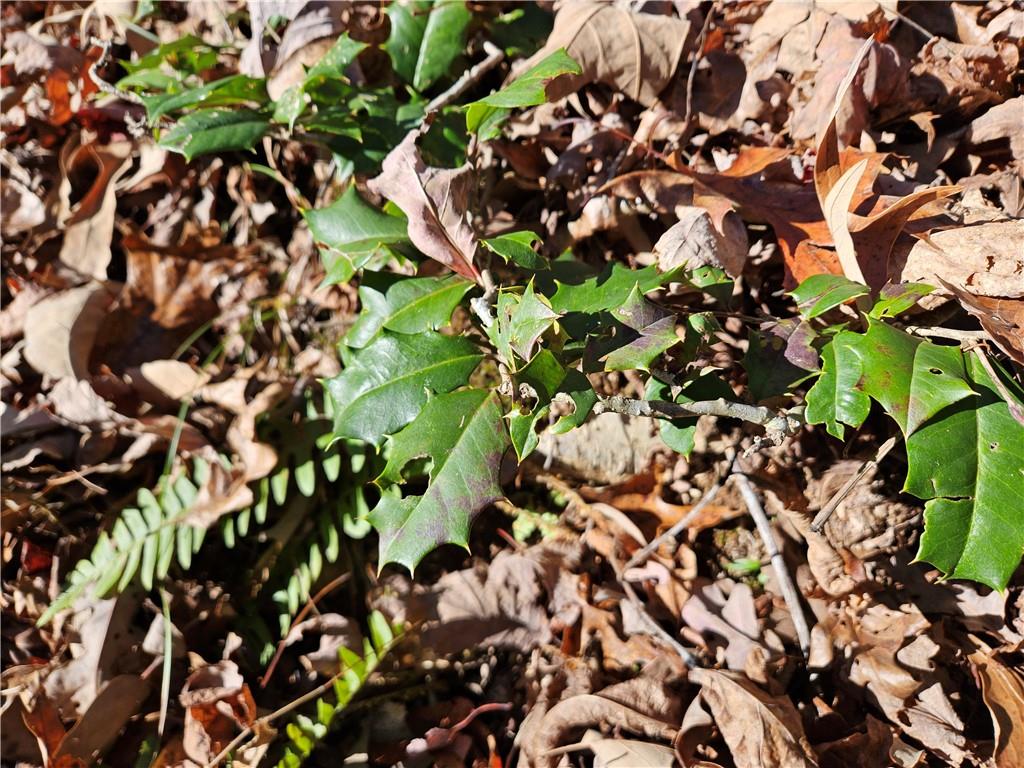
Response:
[[370, 389, 509, 570]]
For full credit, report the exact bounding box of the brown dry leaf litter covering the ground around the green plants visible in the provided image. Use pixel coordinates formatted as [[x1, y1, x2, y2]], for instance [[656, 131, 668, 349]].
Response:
[[0, 0, 1024, 768]]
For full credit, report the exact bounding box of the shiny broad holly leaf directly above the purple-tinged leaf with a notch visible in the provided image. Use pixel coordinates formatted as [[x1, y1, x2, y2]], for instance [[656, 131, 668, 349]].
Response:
[[325, 332, 483, 445]]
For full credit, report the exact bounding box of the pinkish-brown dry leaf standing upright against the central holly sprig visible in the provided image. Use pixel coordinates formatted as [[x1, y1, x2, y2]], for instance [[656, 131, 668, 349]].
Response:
[[368, 129, 480, 281]]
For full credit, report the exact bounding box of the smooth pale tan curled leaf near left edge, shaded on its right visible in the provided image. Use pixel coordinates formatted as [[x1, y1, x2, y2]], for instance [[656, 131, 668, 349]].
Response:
[[25, 283, 114, 379]]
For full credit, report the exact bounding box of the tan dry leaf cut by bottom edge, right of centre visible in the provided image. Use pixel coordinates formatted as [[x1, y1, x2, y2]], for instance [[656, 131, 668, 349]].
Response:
[[690, 670, 818, 768]]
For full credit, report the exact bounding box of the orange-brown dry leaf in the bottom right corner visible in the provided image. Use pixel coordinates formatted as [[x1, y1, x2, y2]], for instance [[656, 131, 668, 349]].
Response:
[[968, 649, 1024, 768]]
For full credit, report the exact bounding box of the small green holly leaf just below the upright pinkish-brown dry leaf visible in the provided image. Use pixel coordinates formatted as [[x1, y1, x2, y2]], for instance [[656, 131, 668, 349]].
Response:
[[345, 274, 473, 349]]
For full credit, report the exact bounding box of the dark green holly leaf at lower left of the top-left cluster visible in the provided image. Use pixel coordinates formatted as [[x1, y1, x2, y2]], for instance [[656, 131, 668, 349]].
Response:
[[159, 110, 270, 162]]
